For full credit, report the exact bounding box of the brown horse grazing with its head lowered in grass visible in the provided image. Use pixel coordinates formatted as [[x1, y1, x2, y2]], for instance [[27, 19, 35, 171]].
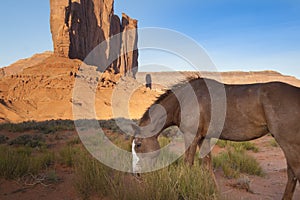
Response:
[[132, 78, 300, 199]]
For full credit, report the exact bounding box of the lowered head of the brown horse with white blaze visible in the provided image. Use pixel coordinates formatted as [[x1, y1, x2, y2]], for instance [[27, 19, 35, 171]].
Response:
[[132, 127, 160, 173]]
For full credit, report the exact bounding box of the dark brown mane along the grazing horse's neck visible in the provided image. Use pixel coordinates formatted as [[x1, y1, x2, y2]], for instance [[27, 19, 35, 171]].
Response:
[[140, 75, 201, 122]]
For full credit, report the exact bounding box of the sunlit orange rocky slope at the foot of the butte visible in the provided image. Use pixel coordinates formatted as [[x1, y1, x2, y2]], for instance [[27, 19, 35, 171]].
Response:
[[0, 55, 157, 123]]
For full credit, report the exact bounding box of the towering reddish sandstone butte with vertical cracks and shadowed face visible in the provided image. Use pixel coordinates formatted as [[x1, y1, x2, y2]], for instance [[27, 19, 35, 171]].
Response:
[[50, 0, 138, 77]]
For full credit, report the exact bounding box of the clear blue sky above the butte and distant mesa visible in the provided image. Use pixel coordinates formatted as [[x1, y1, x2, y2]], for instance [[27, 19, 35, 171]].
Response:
[[0, 0, 300, 78]]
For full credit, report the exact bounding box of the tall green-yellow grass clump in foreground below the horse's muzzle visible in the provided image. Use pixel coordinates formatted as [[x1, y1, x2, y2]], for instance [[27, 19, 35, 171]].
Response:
[[75, 149, 219, 200]]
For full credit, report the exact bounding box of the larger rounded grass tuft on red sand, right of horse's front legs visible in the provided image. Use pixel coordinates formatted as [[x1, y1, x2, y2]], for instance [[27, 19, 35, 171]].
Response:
[[213, 149, 264, 178]]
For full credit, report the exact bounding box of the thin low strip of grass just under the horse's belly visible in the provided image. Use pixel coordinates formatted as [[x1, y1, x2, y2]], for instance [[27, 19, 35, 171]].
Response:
[[217, 139, 259, 153]]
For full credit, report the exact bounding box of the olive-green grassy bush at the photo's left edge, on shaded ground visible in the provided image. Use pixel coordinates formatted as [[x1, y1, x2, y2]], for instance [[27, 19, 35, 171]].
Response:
[[0, 146, 54, 179]]
